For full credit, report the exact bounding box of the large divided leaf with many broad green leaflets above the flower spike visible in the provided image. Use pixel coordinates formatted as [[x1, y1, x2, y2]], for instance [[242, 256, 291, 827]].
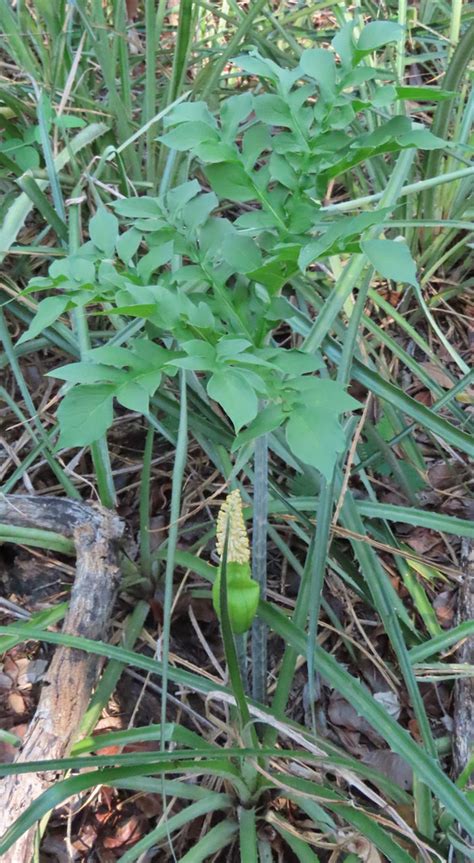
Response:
[[15, 22, 442, 479]]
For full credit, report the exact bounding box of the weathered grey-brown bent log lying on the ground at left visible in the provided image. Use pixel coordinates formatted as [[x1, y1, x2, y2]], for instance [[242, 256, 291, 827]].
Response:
[[0, 495, 123, 863]]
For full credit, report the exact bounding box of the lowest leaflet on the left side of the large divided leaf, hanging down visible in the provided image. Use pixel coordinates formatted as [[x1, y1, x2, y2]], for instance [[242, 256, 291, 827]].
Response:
[[57, 384, 115, 449]]
